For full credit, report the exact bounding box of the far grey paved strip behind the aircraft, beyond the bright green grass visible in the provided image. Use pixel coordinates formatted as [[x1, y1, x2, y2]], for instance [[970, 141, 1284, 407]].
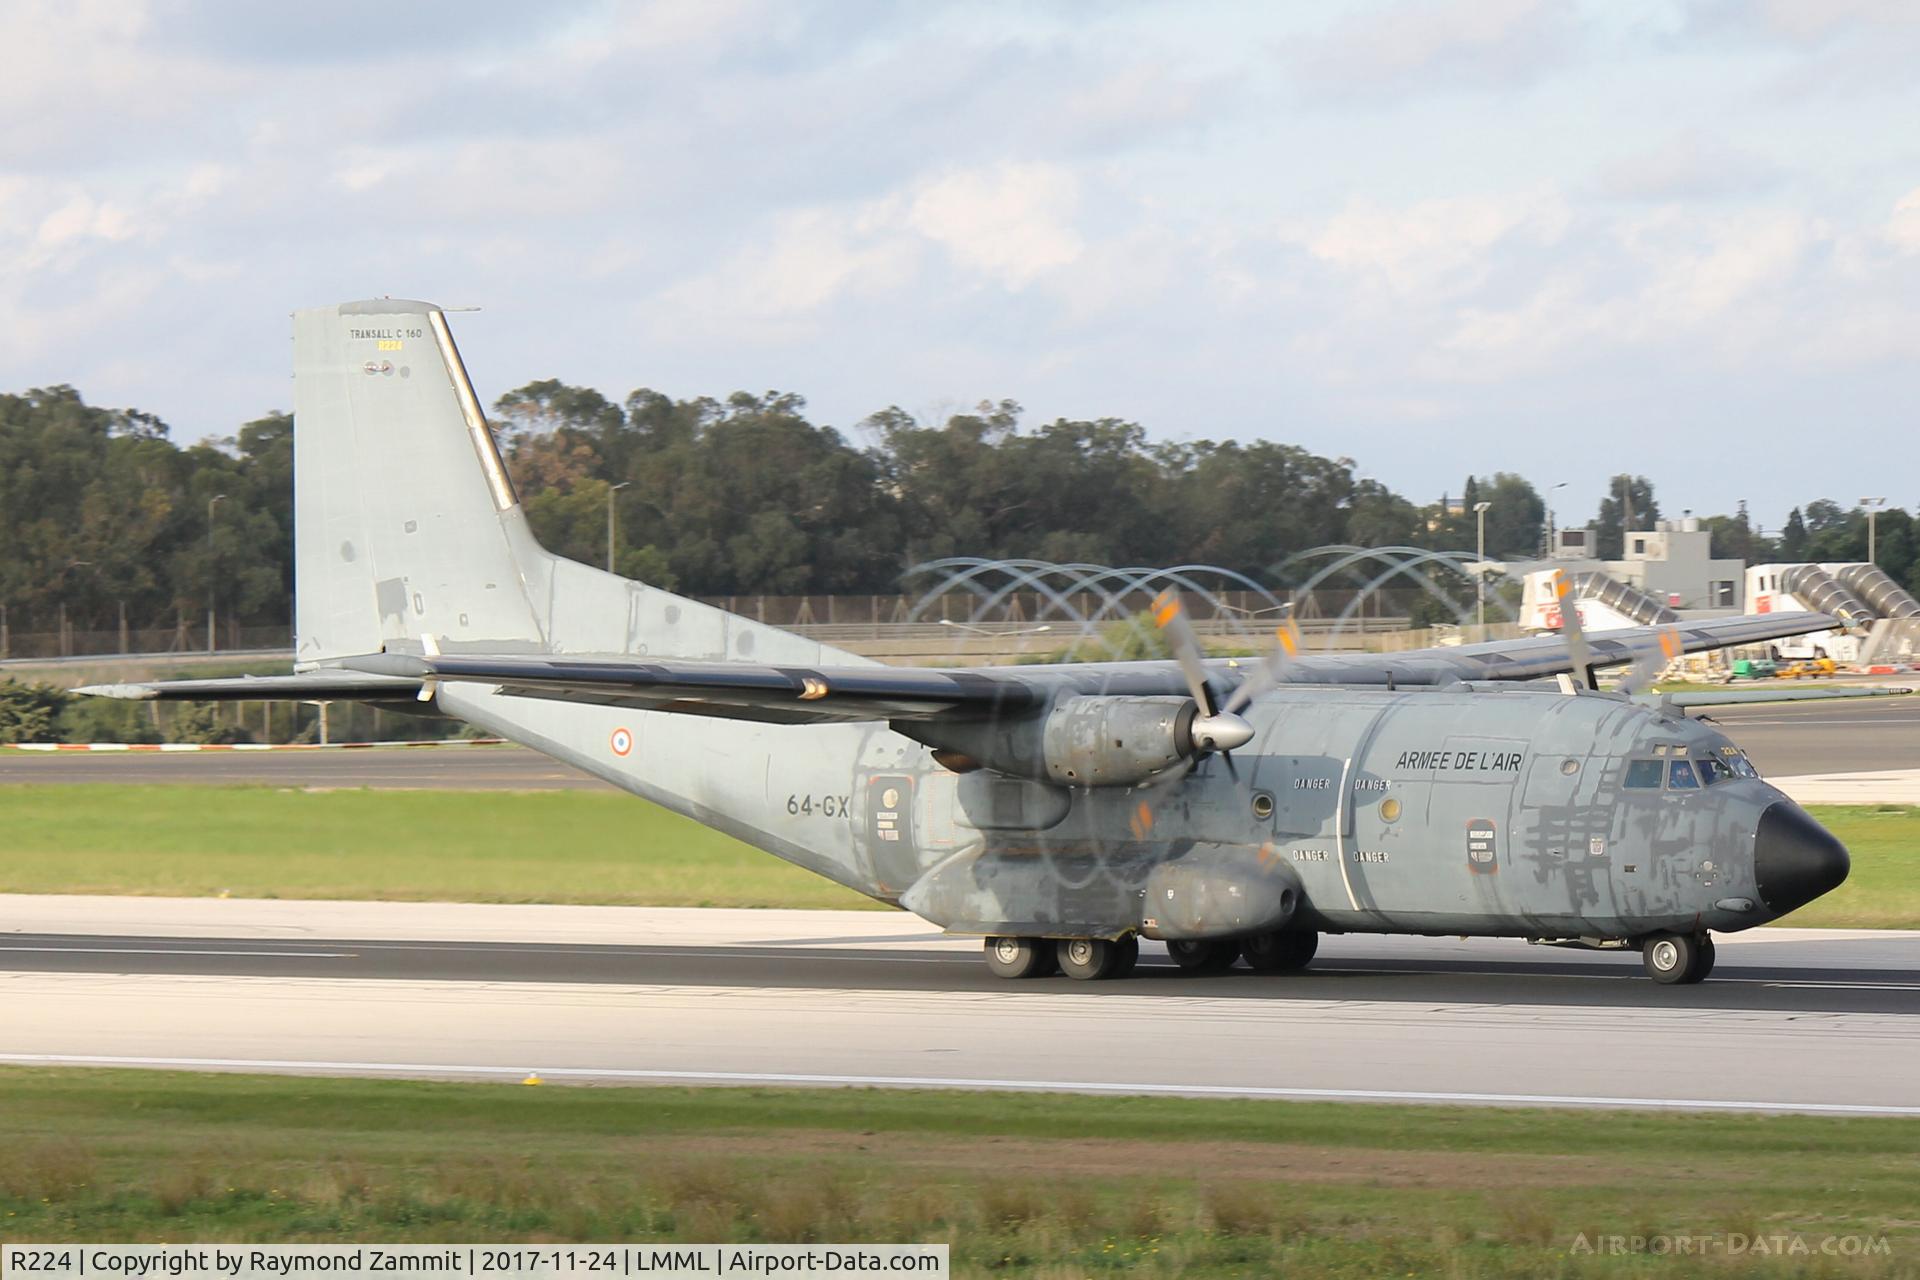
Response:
[[0, 697, 1920, 791]]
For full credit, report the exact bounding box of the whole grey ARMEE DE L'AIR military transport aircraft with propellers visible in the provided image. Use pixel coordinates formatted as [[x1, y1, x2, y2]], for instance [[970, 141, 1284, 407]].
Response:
[[90, 299, 1847, 983]]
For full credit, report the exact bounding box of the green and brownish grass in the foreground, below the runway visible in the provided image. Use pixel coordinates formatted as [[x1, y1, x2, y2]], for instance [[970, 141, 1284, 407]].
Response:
[[0, 1069, 1920, 1276]]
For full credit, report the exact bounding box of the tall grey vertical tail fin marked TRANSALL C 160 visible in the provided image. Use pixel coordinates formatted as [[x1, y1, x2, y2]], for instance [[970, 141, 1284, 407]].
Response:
[[294, 297, 864, 668]]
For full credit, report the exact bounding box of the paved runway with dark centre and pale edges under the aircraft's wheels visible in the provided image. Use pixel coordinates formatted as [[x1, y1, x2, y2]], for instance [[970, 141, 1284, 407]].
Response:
[[0, 896, 1920, 1115]]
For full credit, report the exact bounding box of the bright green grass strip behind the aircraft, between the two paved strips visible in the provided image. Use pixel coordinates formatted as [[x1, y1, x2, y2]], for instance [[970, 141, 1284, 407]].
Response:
[[0, 787, 1920, 929]]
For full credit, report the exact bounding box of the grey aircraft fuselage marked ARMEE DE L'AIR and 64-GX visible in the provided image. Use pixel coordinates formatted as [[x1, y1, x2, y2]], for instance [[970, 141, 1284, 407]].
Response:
[[440, 668, 1811, 938]]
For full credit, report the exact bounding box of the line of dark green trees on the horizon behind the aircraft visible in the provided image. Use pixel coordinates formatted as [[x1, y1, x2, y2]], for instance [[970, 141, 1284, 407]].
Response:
[[0, 380, 1920, 631]]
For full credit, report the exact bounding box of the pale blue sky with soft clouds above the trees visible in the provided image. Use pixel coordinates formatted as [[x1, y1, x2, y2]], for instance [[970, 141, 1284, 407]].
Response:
[[0, 0, 1920, 530]]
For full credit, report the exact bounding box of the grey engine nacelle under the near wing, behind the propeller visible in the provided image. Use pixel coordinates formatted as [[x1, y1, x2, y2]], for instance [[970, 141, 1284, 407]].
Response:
[[895, 695, 1200, 787]]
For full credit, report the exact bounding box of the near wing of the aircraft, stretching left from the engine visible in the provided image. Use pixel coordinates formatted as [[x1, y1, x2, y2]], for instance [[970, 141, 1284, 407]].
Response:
[[353, 654, 1046, 723]]
